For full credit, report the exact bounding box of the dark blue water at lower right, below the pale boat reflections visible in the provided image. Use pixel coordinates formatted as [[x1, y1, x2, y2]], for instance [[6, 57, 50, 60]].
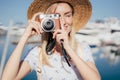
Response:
[[93, 49, 120, 80]]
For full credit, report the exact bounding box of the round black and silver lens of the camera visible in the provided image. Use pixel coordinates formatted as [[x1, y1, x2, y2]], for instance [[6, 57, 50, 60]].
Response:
[[42, 19, 54, 32]]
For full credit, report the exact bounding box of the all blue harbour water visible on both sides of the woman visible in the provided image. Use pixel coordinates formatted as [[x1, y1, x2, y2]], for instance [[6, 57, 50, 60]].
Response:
[[0, 36, 120, 80]]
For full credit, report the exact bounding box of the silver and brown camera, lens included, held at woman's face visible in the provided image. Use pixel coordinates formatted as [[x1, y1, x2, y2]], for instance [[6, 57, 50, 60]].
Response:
[[39, 14, 60, 32]]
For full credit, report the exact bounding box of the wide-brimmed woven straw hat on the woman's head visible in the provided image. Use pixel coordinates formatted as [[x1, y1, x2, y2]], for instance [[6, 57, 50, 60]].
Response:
[[27, 0, 92, 32]]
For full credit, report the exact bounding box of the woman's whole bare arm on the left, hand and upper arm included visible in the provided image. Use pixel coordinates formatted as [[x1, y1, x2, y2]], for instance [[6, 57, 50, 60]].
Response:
[[2, 13, 42, 80]]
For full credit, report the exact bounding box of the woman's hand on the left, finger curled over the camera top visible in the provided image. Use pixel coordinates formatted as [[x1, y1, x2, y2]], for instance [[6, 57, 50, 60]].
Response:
[[23, 12, 43, 38]]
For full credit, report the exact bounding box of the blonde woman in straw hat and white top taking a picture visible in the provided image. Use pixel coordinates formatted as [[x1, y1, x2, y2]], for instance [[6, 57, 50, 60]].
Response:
[[2, 0, 100, 80]]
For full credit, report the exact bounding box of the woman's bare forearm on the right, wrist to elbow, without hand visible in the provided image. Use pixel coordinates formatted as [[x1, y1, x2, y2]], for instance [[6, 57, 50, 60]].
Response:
[[65, 46, 100, 80]]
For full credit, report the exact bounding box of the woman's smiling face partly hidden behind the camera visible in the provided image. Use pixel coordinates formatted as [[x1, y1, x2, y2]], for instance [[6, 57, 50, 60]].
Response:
[[54, 3, 73, 33]]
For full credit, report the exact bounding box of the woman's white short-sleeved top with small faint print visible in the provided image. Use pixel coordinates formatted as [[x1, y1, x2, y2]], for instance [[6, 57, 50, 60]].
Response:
[[24, 43, 94, 80]]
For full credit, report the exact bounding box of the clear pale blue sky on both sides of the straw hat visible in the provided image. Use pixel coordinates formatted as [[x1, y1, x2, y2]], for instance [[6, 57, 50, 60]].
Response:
[[0, 0, 120, 26]]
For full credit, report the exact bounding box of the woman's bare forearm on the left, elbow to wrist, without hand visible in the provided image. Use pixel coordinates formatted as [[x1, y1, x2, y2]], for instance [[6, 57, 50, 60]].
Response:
[[2, 34, 28, 80]]
